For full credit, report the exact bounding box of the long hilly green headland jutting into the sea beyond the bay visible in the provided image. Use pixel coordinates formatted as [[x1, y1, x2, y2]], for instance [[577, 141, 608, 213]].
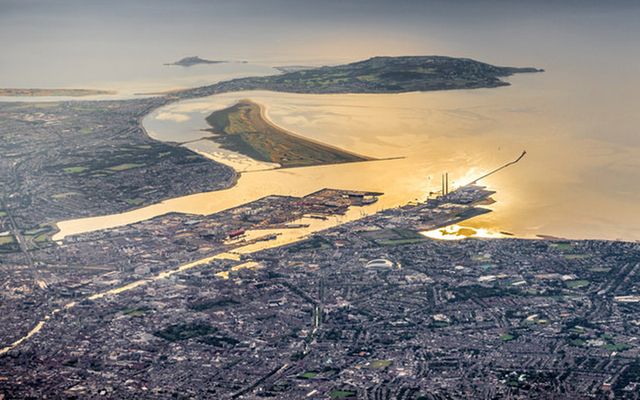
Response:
[[172, 56, 543, 98]]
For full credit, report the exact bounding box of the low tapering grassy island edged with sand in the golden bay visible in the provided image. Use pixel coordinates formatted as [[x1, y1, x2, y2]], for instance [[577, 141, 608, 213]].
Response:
[[207, 100, 370, 168]]
